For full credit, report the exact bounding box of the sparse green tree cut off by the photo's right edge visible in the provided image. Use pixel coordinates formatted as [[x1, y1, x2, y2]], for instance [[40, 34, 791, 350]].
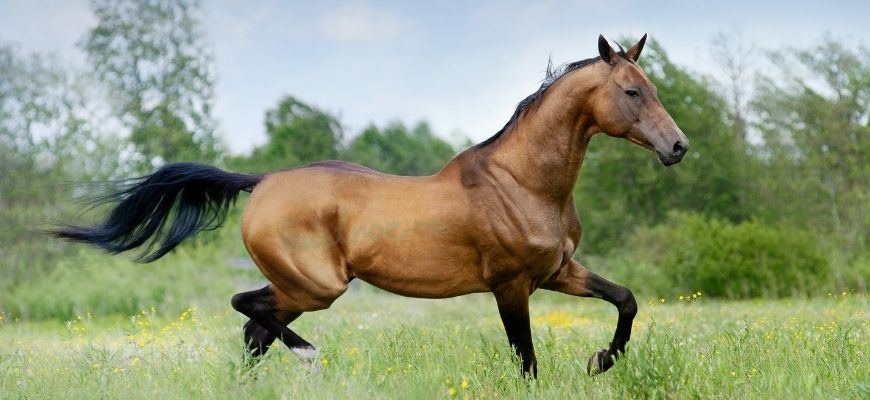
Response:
[[753, 37, 870, 252]]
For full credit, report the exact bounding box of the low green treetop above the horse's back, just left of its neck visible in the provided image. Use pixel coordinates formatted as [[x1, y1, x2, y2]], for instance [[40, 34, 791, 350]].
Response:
[[343, 122, 456, 175]]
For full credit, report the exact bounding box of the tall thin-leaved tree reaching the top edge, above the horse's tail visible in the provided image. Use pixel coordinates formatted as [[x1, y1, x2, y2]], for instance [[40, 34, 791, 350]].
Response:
[[80, 0, 219, 170]]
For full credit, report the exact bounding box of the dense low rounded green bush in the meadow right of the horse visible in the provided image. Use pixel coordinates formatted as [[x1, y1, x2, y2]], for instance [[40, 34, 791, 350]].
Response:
[[628, 214, 831, 298]]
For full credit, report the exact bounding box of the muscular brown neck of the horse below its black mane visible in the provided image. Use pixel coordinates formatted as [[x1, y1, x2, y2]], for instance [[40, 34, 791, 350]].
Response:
[[480, 70, 594, 204]]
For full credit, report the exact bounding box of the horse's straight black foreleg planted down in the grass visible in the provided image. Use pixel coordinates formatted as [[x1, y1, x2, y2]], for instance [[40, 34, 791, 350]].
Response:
[[493, 284, 538, 378]]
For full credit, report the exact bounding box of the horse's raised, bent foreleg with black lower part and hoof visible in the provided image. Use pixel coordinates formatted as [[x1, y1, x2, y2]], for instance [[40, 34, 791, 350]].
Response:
[[541, 259, 637, 375]]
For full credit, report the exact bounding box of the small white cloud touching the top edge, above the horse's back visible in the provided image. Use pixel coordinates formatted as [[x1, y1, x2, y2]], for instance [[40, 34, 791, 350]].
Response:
[[317, 2, 402, 43]]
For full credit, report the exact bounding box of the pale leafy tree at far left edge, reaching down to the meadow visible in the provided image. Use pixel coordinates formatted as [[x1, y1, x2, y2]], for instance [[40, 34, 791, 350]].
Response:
[[0, 42, 124, 292]]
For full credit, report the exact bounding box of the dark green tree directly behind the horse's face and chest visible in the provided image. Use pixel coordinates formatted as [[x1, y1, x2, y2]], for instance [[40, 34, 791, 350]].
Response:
[[575, 42, 752, 254]]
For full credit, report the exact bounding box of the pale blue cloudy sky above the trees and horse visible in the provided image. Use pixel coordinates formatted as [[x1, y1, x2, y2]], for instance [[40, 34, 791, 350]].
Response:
[[0, 0, 870, 154]]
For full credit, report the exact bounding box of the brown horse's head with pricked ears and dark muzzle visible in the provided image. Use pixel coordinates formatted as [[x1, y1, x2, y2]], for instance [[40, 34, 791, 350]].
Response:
[[592, 35, 689, 165]]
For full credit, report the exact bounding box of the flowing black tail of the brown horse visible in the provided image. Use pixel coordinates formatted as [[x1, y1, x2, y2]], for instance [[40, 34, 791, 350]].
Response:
[[52, 163, 262, 262]]
